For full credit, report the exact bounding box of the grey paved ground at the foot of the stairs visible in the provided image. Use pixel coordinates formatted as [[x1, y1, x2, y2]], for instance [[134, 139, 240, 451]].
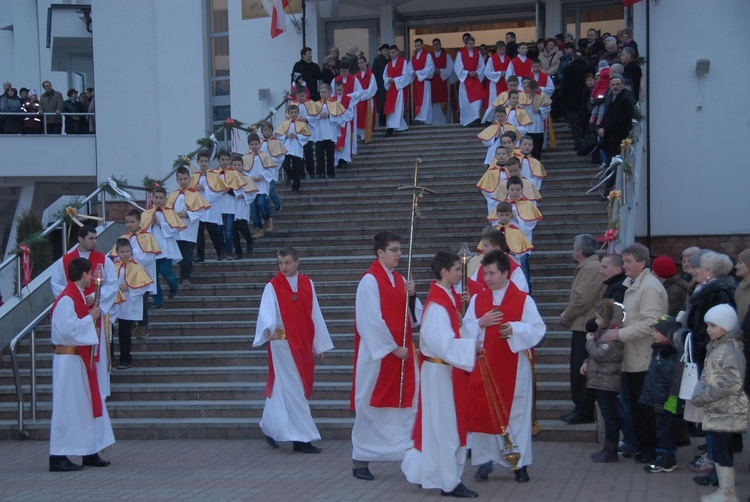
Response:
[[0, 437, 750, 502]]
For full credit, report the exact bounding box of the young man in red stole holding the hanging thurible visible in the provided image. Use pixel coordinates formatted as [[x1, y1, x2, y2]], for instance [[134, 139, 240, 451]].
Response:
[[464, 251, 546, 483]]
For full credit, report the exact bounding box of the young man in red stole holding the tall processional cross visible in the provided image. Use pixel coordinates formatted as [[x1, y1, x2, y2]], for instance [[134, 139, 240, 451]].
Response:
[[352, 232, 422, 481]]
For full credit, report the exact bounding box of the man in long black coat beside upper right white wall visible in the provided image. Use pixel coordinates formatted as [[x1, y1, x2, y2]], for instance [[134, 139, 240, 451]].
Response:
[[598, 74, 633, 164]]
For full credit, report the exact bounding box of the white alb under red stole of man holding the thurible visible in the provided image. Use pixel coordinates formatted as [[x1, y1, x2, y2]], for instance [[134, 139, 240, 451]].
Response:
[[464, 286, 547, 467]]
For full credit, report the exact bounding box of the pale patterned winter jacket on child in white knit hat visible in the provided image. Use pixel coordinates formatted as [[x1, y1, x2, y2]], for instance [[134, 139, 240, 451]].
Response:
[[692, 330, 748, 432]]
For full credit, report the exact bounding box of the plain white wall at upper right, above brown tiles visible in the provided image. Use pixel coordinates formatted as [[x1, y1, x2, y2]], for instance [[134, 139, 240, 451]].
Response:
[[648, 0, 750, 235]]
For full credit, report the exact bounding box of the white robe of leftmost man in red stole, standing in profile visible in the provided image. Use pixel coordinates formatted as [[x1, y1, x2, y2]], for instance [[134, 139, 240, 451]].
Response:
[[49, 289, 115, 455]]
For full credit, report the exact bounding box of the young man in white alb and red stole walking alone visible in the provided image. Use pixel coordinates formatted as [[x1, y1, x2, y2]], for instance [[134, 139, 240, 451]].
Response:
[[253, 248, 333, 453]]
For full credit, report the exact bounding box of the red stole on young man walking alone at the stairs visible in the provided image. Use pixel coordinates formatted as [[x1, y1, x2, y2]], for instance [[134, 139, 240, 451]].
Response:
[[266, 272, 315, 399]]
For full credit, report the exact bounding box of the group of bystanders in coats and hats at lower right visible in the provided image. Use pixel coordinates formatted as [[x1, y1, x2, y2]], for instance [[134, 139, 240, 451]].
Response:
[[560, 239, 750, 501]]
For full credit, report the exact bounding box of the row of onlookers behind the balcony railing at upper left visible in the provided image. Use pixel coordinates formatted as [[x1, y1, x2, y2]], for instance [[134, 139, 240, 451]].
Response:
[[0, 80, 96, 134]]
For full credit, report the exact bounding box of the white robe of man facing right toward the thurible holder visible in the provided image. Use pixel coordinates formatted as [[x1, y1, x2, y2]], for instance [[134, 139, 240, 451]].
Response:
[[401, 286, 476, 492]]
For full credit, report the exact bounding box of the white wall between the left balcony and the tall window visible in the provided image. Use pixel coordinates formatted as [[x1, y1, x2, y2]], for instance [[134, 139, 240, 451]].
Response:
[[91, 0, 207, 190]]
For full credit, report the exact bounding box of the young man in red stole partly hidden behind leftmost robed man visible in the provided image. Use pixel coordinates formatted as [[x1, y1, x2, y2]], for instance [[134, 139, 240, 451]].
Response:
[[50, 225, 118, 399]]
